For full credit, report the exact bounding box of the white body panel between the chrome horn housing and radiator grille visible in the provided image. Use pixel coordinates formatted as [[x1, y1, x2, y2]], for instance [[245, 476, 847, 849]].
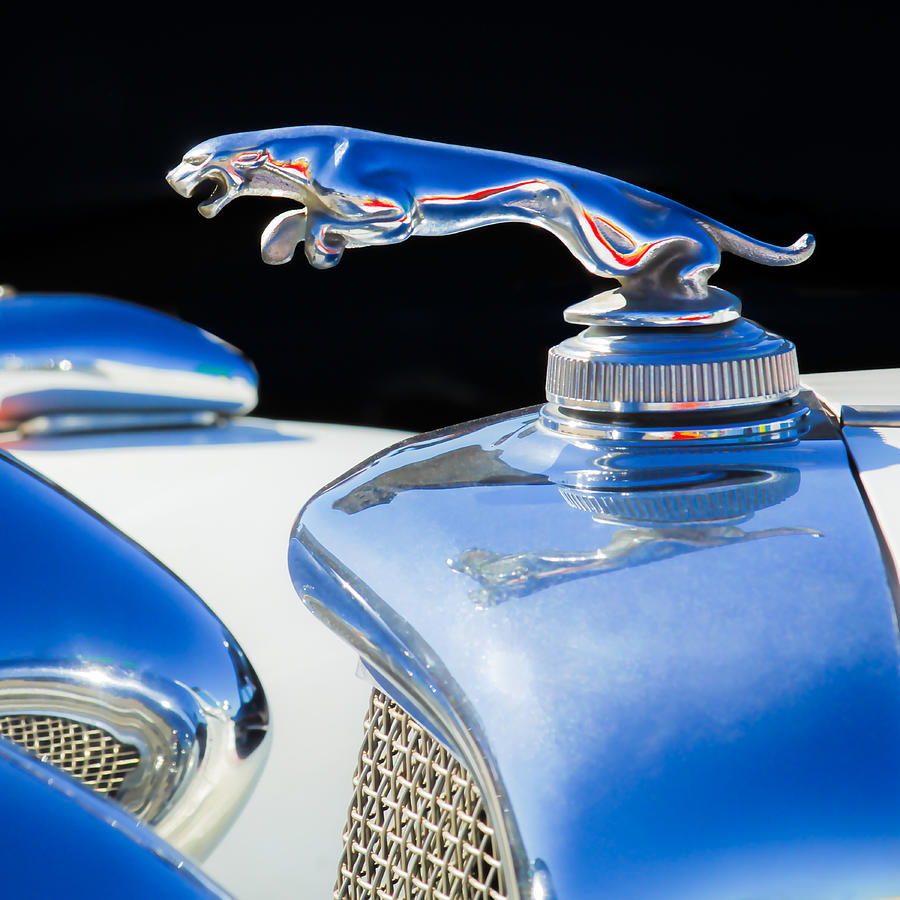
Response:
[[5, 419, 406, 900]]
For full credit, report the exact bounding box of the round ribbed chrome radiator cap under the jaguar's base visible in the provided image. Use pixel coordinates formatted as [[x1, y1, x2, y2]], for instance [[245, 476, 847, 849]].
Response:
[[546, 290, 800, 413]]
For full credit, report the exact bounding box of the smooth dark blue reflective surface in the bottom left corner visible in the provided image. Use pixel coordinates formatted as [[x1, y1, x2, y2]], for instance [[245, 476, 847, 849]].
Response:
[[0, 740, 228, 900]]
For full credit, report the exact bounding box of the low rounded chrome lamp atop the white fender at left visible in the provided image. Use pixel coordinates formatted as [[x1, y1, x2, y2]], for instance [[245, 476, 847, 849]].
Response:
[[0, 294, 257, 432]]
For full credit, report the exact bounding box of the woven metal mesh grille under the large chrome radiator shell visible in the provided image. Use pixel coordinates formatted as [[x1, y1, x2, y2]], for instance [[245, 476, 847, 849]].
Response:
[[334, 690, 506, 900]]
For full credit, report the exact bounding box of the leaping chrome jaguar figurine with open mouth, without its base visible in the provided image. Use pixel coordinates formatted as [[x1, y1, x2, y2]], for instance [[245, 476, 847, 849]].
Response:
[[167, 125, 814, 299]]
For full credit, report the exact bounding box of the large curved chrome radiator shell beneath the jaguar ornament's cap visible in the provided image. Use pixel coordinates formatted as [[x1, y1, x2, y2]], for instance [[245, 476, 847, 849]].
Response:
[[289, 397, 900, 900]]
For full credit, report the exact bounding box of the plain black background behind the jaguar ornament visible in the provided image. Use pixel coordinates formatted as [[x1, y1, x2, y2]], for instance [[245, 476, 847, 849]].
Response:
[[0, 14, 900, 429]]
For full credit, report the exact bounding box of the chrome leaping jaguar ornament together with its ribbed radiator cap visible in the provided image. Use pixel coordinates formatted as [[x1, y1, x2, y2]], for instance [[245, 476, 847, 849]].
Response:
[[168, 126, 814, 413]]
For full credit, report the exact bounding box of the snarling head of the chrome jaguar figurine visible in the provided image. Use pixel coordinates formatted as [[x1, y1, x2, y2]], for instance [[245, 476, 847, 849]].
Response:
[[166, 131, 315, 219]]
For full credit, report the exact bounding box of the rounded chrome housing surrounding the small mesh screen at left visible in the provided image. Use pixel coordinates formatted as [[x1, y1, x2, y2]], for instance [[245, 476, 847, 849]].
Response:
[[0, 454, 269, 857]]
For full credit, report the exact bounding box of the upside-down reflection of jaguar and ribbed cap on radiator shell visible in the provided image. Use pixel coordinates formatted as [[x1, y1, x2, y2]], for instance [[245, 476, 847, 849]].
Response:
[[447, 466, 823, 609]]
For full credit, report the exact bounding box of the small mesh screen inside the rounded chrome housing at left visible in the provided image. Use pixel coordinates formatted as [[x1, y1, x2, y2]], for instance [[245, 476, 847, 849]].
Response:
[[0, 715, 141, 797]]
